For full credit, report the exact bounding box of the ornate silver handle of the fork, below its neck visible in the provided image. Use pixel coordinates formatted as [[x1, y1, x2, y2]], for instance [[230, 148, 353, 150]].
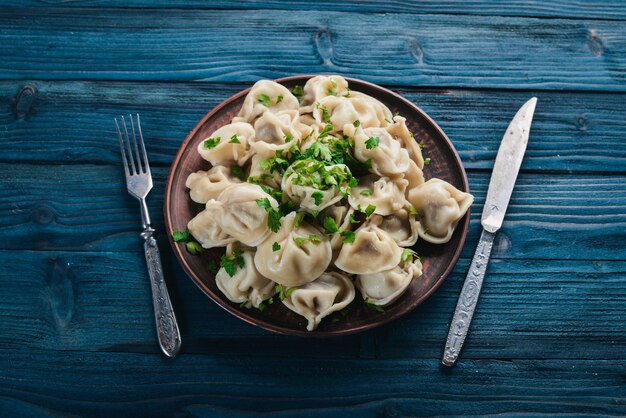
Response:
[[141, 227, 181, 357]]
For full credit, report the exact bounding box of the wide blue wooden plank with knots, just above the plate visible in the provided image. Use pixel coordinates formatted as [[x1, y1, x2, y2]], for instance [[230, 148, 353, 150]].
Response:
[[0, 8, 626, 92]]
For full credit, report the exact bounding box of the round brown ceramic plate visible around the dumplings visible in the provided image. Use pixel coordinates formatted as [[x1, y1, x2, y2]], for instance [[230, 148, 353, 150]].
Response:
[[164, 76, 469, 337]]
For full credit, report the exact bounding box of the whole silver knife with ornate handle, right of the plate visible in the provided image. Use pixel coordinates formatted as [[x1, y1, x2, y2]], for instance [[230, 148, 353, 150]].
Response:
[[441, 97, 537, 366]]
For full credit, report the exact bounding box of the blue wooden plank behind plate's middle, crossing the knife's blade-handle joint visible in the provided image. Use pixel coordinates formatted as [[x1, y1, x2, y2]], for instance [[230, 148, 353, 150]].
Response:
[[0, 164, 626, 260]]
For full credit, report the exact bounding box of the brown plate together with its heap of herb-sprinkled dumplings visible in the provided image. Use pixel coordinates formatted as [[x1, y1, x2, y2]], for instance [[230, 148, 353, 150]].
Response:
[[164, 75, 473, 336]]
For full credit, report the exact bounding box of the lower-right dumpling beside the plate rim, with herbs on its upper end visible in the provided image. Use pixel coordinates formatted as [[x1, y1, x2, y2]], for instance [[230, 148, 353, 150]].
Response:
[[356, 258, 422, 306]]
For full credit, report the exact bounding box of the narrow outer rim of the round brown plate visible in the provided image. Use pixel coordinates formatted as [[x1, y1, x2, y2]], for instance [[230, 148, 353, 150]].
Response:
[[163, 74, 471, 338]]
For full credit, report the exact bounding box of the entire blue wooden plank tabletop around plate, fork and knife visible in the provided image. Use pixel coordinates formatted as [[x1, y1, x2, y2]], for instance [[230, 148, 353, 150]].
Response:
[[0, 0, 626, 417]]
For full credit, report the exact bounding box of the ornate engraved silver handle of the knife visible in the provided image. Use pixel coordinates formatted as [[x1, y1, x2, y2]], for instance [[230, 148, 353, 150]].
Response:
[[441, 229, 496, 366]]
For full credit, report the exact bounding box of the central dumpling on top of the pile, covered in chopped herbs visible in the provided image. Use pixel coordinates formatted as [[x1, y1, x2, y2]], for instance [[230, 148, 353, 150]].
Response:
[[282, 160, 350, 212]]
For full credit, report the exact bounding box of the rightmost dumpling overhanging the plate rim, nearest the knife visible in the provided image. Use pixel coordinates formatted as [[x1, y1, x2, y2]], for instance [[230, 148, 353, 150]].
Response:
[[409, 178, 474, 244]]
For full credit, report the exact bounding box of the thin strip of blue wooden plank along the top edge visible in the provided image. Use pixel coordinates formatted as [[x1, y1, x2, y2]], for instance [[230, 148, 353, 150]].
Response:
[[0, 0, 626, 20]]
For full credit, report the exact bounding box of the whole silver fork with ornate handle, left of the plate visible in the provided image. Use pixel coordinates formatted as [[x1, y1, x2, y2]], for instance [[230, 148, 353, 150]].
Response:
[[114, 114, 181, 357]]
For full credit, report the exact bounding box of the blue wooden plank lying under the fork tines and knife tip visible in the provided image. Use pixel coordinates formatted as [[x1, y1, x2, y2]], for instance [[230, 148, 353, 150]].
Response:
[[0, 81, 626, 173]]
